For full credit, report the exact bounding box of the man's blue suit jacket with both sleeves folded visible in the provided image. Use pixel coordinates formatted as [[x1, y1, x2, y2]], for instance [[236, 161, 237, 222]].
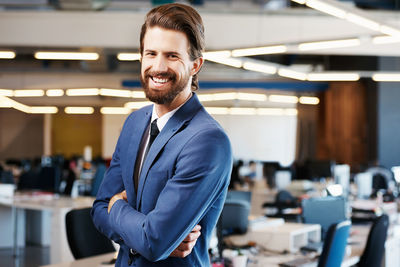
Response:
[[92, 94, 232, 267]]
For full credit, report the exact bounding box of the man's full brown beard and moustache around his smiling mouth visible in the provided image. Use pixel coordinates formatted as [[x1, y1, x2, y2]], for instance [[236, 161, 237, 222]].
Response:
[[140, 70, 190, 105]]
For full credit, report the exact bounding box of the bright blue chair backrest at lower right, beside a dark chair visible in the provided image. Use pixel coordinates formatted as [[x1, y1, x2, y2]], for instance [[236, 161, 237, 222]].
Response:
[[318, 220, 351, 267]]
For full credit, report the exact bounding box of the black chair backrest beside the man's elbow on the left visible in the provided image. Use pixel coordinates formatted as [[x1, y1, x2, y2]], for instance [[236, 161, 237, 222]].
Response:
[[65, 208, 115, 259]]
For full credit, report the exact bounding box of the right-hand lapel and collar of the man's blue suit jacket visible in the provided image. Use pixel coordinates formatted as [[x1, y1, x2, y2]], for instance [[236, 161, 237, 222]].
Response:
[[136, 93, 202, 210]]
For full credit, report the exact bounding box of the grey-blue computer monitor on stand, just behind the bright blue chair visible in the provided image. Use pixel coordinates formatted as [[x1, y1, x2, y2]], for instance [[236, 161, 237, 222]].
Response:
[[301, 197, 347, 239]]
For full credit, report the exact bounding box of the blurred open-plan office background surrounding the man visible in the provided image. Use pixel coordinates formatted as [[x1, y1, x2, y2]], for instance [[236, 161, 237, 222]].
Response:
[[0, 0, 400, 267]]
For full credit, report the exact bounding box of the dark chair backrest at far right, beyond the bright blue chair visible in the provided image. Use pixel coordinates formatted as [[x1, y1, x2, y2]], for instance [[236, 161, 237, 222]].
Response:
[[358, 214, 389, 267]]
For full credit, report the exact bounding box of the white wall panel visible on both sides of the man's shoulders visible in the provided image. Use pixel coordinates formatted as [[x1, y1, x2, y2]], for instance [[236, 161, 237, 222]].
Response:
[[103, 112, 297, 166]]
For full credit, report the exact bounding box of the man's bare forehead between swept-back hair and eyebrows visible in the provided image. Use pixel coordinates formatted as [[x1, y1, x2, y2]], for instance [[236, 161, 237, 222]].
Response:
[[143, 27, 189, 53]]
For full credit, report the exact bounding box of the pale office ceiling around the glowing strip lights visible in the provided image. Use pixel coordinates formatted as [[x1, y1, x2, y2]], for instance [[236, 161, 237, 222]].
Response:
[[0, 0, 400, 110]]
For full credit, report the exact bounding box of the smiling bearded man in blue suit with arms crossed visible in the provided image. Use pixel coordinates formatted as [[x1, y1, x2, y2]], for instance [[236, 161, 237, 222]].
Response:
[[92, 4, 232, 267]]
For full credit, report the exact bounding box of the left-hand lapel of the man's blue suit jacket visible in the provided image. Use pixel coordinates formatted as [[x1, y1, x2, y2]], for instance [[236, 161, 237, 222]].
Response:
[[123, 107, 151, 205]]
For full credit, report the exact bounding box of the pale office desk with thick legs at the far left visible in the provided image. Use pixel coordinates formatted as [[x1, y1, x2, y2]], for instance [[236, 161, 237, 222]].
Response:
[[0, 193, 94, 263]]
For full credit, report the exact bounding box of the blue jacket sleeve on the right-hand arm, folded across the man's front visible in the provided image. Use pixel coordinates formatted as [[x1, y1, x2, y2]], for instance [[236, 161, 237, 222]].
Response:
[[108, 128, 232, 261]]
